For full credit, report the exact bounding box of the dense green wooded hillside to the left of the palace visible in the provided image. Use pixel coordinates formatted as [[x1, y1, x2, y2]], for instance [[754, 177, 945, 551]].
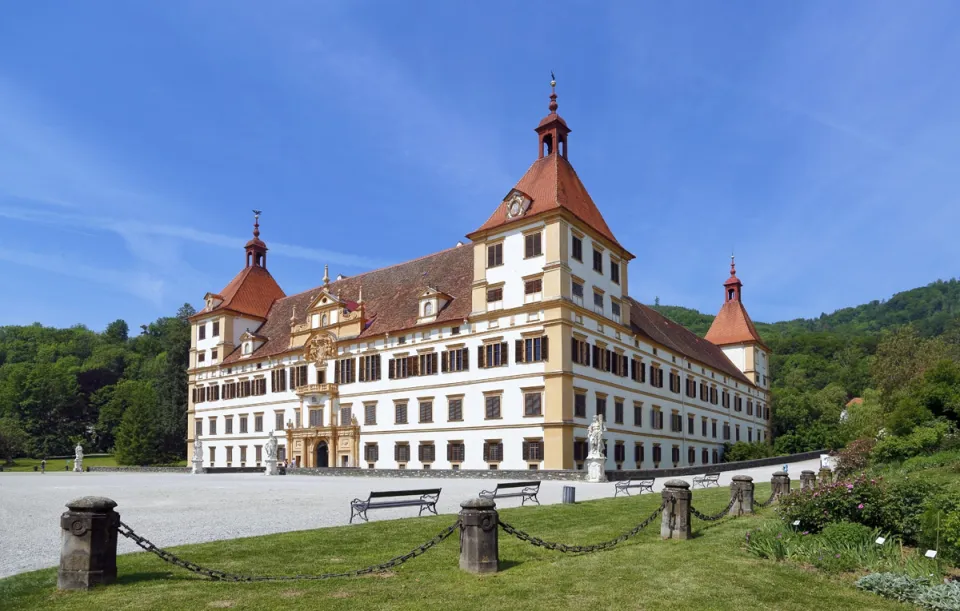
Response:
[[0, 305, 194, 464]]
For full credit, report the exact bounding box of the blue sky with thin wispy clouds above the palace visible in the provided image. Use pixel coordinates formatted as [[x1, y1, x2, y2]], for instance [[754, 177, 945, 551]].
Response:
[[0, 0, 960, 329]]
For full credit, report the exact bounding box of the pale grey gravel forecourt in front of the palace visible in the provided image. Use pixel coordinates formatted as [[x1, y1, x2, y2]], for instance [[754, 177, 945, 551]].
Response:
[[0, 459, 819, 577]]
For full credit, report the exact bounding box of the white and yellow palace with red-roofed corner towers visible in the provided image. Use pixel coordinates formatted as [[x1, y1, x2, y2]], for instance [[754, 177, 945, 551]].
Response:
[[187, 82, 770, 470]]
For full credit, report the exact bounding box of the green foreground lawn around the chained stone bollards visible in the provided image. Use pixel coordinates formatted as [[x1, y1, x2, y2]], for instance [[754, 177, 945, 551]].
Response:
[[0, 484, 908, 611]]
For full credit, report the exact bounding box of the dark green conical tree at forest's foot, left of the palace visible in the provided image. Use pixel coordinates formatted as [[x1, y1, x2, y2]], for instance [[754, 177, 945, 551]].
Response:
[[115, 382, 166, 465]]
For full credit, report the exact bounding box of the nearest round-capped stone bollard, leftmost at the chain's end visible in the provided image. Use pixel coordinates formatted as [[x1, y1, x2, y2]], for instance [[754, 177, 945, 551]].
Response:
[[57, 496, 120, 590]]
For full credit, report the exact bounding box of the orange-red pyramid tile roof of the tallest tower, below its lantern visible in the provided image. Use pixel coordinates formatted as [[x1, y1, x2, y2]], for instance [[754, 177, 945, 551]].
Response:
[[467, 153, 626, 250]]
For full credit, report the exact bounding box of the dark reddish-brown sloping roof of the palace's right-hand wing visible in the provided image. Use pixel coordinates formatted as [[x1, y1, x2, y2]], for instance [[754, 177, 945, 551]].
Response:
[[630, 297, 753, 386]]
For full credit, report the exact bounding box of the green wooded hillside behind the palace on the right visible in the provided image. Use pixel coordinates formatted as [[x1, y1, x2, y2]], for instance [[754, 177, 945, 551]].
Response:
[[653, 279, 960, 452]]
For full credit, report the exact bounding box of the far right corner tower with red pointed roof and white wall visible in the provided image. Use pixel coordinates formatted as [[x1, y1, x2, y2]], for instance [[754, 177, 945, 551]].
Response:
[[706, 255, 770, 389]]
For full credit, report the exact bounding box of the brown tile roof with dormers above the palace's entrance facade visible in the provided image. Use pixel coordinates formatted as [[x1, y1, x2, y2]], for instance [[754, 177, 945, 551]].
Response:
[[223, 245, 473, 364]]
